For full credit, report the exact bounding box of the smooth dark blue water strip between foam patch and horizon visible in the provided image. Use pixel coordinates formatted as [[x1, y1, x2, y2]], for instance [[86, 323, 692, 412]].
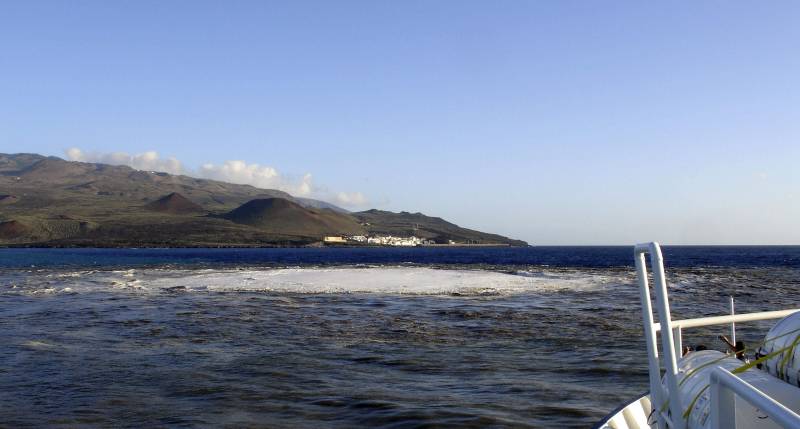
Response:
[[0, 246, 800, 268]]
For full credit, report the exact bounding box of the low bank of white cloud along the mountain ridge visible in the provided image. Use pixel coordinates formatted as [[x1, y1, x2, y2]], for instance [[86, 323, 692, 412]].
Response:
[[66, 148, 369, 207]]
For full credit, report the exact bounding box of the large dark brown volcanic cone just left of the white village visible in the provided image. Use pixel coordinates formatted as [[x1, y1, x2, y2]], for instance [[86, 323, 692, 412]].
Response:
[[223, 198, 364, 239]]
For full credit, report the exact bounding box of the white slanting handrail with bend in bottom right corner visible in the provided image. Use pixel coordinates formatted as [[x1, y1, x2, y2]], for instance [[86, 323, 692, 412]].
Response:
[[710, 368, 800, 429]]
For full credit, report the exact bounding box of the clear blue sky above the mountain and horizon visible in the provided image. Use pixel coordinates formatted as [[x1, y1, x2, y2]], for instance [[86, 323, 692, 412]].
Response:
[[0, 1, 800, 244]]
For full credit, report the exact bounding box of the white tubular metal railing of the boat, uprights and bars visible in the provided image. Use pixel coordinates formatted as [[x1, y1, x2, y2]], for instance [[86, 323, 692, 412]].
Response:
[[634, 242, 800, 429]]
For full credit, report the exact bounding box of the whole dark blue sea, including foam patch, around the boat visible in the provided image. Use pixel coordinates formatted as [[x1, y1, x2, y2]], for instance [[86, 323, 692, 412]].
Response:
[[0, 246, 800, 428]]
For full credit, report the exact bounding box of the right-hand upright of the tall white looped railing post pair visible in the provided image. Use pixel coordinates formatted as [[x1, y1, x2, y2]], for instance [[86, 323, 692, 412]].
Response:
[[650, 242, 686, 429]]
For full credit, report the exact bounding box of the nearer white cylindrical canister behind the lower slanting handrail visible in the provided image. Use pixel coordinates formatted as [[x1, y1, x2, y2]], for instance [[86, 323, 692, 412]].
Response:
[[654, 350, 800, 429]]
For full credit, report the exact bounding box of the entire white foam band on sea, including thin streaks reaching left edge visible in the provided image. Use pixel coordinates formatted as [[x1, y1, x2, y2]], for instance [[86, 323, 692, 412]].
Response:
[[1, 267, 625, 295]]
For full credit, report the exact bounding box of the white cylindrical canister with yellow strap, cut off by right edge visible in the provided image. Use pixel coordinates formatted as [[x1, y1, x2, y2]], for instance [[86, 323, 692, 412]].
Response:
[[758, 313, 800, 387]]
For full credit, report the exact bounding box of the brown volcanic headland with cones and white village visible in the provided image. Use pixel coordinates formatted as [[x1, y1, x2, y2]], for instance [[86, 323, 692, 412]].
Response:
[[0, 153, 527, 247]]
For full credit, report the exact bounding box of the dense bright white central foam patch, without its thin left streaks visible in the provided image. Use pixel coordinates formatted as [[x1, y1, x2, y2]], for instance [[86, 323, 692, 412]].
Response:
[[124, 267, 610, 295]]
